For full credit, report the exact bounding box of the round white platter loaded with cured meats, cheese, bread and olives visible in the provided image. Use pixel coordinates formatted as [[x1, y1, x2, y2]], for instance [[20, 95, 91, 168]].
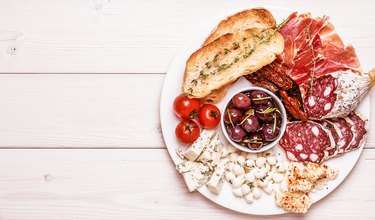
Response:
[[160, 7, 374, 215]]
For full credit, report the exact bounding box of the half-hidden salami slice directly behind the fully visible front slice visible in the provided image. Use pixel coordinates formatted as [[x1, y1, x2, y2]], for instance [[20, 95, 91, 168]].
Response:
[[329, 118, 354, 154]]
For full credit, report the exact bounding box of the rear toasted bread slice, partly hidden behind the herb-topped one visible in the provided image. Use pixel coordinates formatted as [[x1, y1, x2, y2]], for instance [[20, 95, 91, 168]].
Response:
[[203, 8, 276, 46]]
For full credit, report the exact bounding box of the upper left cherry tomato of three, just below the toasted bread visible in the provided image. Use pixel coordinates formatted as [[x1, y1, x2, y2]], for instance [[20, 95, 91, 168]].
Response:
[[173, 94, 201, 120]]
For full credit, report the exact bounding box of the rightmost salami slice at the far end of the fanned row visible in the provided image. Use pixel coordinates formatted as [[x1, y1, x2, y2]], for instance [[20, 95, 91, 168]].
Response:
[[345, 112, 368, 152]]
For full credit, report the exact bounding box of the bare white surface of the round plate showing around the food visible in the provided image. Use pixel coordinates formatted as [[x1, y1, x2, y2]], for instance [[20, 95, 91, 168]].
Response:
[[160, 6, 370, 215]]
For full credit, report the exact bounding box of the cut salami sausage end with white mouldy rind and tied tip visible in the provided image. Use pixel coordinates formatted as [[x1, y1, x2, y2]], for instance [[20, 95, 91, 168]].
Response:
[[301, 71, 375, 120]]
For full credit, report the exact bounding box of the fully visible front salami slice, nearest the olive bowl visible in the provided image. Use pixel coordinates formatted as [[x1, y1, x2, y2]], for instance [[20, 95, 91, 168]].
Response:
[[279, 121, 335, 163]]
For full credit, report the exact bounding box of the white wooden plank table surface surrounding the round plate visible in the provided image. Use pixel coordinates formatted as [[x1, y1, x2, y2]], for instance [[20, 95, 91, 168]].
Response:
[[0, 0, 375, 220]]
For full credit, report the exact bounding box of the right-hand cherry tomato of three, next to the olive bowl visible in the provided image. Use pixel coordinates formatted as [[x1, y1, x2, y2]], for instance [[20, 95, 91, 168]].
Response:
[[198, 104, 221, 129]]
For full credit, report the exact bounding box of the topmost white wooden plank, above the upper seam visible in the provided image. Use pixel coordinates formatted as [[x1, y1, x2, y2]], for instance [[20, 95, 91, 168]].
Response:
[[0, 0, 375, 73]]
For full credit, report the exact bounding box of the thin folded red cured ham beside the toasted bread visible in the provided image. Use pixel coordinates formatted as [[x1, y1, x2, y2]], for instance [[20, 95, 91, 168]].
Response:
[[278, 12, 361, 85]]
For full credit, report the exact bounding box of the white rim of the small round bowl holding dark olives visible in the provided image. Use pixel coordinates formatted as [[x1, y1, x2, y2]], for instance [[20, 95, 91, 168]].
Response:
[[220, 86, 287, 153]]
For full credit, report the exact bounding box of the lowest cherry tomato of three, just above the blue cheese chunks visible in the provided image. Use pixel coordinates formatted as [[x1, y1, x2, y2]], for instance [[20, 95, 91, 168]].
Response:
[[175, 121, 200, 144]]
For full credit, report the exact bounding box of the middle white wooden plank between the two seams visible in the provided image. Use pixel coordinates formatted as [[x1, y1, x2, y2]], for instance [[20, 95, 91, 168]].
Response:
[[0, 74, 375, 148]]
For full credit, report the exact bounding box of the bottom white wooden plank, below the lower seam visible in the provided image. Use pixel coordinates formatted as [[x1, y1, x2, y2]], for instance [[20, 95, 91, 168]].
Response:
[[0, 149, 375, 220]]
